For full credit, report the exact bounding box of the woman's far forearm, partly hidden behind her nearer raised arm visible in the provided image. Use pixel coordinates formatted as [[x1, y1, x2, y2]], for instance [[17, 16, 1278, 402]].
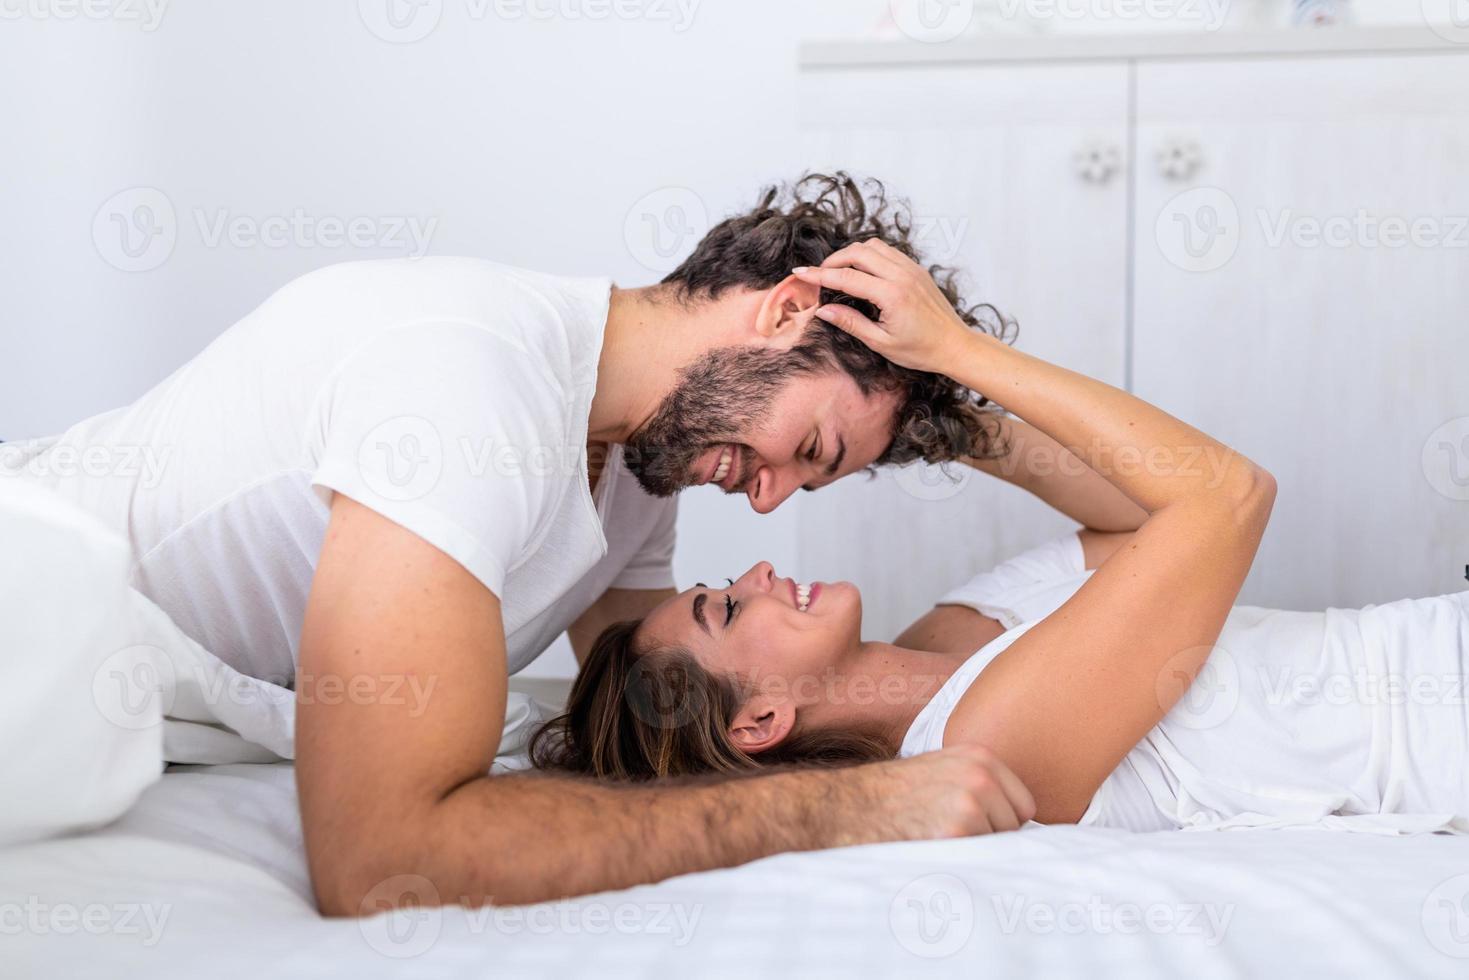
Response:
[[967, 417, 1147, 530]]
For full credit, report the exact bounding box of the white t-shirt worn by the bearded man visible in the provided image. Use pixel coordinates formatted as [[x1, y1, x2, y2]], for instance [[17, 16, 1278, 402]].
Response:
[[0, 259, 676, 683]]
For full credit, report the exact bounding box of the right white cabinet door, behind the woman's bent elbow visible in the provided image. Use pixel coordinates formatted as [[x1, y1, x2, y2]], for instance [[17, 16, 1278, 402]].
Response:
[[1134, 53, 1469, 608]]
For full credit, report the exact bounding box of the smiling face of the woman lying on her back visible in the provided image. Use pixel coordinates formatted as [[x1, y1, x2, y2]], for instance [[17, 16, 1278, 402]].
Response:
[[640, 561, 862, 705]]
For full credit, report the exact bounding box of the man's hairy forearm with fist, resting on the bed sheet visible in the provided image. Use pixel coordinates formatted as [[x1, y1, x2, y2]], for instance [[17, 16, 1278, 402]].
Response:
[[307, 745, 1036, 915]]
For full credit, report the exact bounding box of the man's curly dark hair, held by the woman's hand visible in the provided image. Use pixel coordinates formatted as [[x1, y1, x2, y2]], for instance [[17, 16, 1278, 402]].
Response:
[[663, 170, 1015, 466]]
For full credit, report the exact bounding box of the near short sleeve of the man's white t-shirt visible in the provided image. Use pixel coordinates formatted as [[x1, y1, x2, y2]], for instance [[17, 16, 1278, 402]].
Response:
[[311, 323, 567, 595]]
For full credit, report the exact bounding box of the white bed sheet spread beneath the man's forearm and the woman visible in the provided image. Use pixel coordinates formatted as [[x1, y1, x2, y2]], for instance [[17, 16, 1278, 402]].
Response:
[[0, 764, 1469, 980]]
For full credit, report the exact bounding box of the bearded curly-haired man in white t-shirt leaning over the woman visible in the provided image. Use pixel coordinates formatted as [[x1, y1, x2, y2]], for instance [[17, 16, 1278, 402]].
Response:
[[8, 175, 1145, 914]]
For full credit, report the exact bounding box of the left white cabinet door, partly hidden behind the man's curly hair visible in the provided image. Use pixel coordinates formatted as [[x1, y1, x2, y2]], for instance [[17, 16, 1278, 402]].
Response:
[[798, 65, 1127, 639]]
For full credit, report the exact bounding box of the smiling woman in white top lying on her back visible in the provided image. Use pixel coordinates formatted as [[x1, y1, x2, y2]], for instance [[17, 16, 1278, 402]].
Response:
[[533, 242, 1469, 830]]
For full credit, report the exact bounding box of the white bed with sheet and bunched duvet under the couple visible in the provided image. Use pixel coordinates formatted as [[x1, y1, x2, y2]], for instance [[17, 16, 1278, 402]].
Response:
[[0, 482, 1469, 980]]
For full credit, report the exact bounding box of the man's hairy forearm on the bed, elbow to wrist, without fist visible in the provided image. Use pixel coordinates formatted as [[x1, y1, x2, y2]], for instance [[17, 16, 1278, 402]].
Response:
[[317, 767, 857, 915]]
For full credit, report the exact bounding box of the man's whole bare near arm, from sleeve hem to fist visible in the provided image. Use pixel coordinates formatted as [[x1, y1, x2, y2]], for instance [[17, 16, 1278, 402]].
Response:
[[297, 495, 1034, 915]]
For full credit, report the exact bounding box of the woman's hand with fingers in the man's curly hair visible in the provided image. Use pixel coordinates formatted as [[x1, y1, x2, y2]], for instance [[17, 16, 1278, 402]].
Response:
[[792, 238, 971, 375]]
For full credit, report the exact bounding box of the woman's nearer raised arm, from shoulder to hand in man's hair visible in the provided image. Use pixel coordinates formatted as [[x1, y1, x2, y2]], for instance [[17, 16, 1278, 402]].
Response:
[[798, 242, 1275, 821]]
